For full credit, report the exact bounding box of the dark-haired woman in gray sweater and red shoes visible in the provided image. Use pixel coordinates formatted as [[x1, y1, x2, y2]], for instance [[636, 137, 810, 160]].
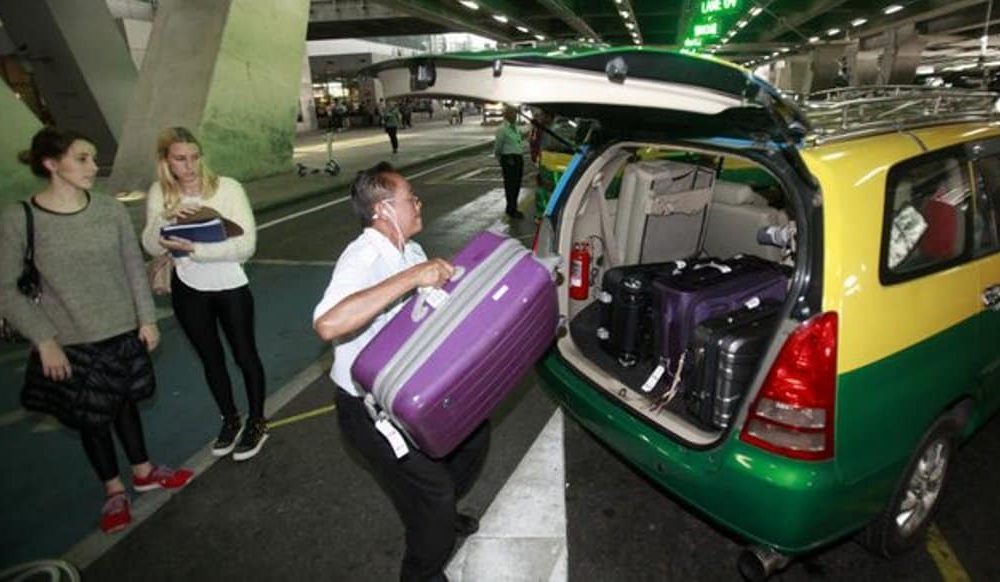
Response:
[[0, 128, 193, 533]]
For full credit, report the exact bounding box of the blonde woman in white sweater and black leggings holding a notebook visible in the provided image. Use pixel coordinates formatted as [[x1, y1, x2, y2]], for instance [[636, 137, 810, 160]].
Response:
[[142, 127, 268, 461]]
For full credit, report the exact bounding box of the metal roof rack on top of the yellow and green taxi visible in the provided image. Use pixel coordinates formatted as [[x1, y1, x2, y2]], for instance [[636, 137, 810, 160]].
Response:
[[798, 85, 998, 143]]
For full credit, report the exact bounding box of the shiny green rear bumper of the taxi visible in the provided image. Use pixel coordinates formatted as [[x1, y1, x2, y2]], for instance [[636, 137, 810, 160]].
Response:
[[539, 352, 878, 554]]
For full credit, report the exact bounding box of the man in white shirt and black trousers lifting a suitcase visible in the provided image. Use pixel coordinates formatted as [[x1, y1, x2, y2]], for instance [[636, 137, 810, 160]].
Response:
[[313, 162, 490, 582]]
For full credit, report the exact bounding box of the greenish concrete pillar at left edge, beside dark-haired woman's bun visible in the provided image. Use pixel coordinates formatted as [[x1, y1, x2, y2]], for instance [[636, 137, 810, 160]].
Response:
[[0, 81, 45, 207]]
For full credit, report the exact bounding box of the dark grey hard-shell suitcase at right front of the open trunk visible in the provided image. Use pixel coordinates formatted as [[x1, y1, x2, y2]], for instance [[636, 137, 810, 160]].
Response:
[[683, 301, 781, 429]]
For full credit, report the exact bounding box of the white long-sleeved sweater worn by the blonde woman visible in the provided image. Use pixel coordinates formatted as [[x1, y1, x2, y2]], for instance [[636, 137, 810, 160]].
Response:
[[142, 177, 257, 291]]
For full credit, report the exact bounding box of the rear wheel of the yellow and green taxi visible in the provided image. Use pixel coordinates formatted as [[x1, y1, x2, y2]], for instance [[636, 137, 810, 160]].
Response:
[[860, 416, 958, 558]]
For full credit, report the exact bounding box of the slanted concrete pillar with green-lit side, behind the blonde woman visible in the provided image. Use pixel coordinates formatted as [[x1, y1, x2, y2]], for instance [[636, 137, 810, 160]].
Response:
[[110, 0, 309, 192]]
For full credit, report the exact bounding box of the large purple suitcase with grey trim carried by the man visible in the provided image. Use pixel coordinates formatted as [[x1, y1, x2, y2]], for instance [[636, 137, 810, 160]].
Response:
[[351, 231, 558, 458]]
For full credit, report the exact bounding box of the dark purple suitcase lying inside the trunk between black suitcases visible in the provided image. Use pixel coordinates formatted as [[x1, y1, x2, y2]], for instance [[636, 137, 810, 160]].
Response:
[[653, 255, 788, 374]]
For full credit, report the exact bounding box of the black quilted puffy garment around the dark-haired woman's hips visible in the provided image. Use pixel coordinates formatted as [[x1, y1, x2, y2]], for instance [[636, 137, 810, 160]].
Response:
[[21, 330, 156, 429]]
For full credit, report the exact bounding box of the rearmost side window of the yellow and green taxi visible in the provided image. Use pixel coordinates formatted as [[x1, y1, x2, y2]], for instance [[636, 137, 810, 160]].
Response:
[[882, 153, 972, 282]]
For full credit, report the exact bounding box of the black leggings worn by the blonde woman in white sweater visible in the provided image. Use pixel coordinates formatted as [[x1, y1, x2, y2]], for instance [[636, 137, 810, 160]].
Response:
[[170, 273, 265, 419]]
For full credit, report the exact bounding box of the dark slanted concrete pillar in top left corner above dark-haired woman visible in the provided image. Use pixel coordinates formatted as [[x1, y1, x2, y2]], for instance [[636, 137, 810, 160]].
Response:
[[0, 0, 136, 166]]
